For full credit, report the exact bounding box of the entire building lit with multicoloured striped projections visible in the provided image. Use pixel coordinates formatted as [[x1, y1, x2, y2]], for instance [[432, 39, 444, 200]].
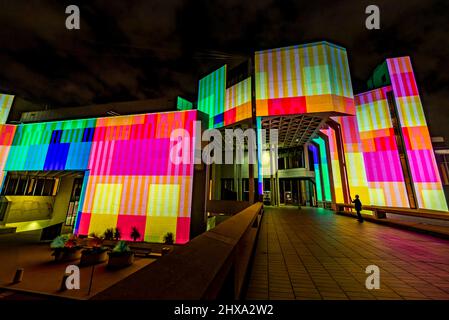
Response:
[[0, 42, 447, 243]]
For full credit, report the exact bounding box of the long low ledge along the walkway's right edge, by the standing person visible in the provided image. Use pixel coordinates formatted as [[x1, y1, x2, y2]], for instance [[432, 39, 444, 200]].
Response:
[[336, 203, 449, 221]]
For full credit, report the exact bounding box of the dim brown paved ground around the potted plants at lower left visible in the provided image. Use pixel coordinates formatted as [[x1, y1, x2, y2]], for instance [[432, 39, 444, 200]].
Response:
[[0, 242, 156, 300]]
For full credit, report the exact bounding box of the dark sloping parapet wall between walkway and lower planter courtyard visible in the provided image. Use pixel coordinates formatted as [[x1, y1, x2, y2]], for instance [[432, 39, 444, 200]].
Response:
[[93, 203, 263, 300]]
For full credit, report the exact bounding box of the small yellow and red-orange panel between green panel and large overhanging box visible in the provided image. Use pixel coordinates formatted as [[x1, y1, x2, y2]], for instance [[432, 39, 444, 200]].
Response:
[[224, 78, 252, 126]]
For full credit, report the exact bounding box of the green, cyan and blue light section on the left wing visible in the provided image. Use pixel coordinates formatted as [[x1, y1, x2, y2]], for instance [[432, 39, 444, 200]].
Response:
[[5, 119, 96, 171]]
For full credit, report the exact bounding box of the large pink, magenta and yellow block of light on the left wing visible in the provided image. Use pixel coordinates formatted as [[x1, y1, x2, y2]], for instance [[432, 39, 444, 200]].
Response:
[[76, 110, 198, 243]]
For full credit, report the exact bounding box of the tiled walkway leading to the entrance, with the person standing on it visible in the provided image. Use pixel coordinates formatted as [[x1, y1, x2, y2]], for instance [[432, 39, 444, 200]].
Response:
[[246, 207, 449, 299]]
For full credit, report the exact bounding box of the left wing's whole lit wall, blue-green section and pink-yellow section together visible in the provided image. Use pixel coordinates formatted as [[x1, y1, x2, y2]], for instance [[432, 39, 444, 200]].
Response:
[[0, 110, 197, 243]]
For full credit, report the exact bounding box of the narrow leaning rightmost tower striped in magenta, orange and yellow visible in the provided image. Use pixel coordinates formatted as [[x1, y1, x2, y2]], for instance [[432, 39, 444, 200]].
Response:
[[387, 57, 448, 211]]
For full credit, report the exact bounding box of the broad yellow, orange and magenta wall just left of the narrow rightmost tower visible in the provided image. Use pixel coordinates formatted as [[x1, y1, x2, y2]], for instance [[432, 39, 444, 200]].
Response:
[[355, 86, 410, 207]]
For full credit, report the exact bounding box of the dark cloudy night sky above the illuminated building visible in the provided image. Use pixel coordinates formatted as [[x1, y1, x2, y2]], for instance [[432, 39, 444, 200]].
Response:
[[0, 0, 449, 139]]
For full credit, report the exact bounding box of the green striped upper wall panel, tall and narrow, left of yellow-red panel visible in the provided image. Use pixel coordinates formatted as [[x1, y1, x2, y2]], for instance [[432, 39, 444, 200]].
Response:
[[198, 65, 226, 128]]
